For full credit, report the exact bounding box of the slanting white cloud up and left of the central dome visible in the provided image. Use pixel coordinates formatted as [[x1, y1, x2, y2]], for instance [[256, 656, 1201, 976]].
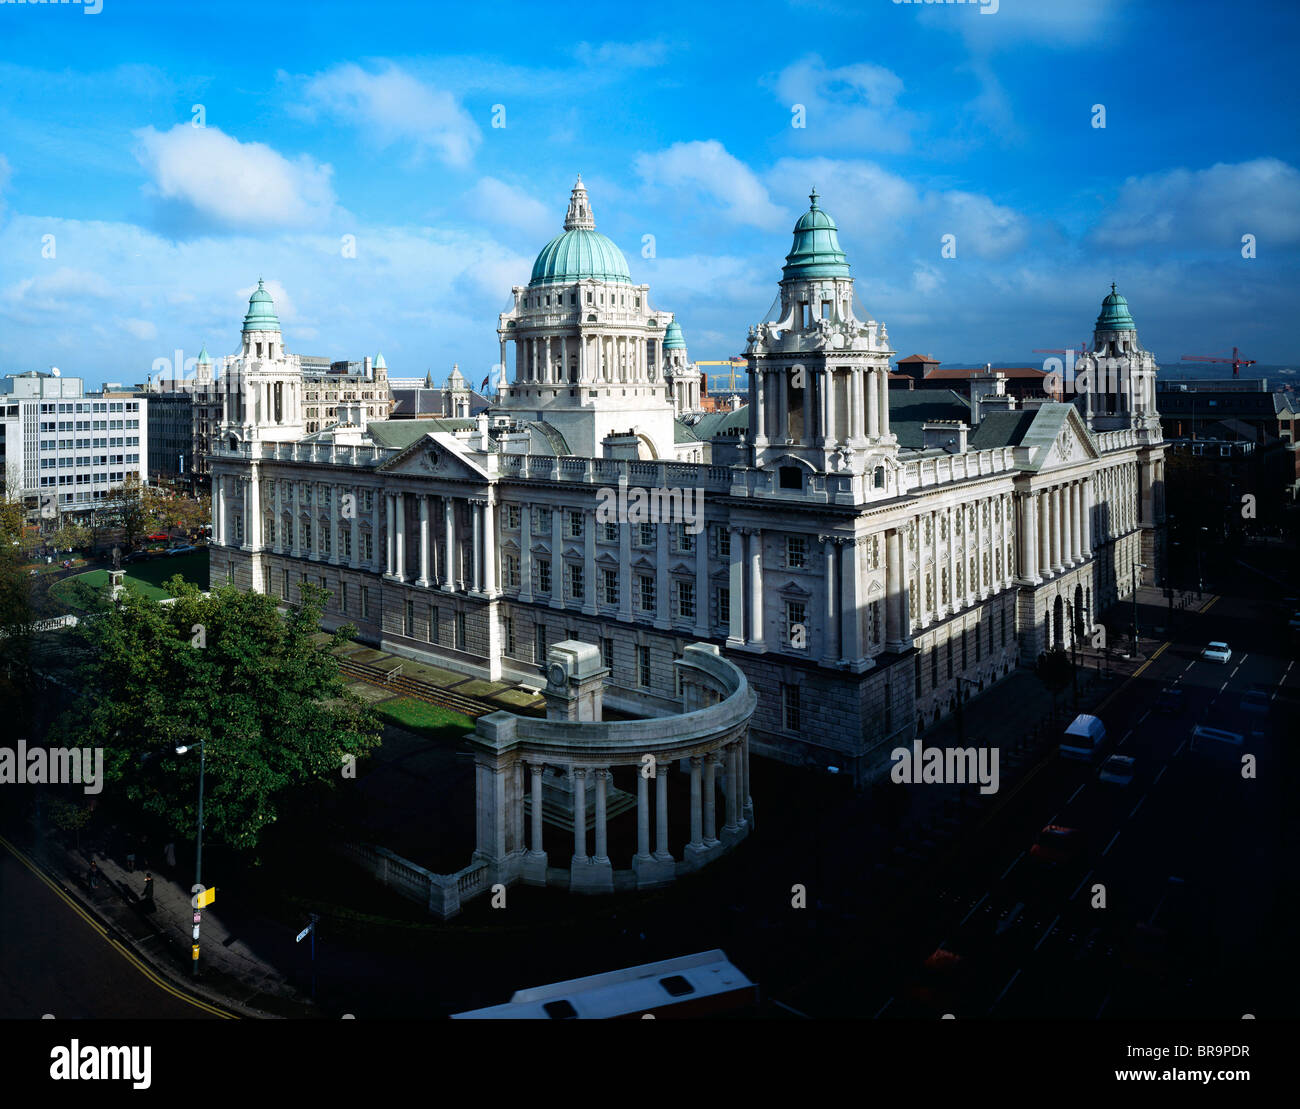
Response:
[[300, 62, 482, 166]]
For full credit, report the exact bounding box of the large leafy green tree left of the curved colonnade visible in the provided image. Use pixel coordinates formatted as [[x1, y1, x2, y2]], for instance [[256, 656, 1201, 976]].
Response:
[[55, 575, 380, 850]]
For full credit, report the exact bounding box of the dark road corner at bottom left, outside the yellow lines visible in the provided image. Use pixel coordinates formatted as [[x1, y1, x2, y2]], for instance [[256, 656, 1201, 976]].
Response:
[[0, 844, 226, 1021]]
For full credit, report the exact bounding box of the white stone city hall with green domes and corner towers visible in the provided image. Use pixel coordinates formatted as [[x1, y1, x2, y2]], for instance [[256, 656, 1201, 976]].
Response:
[[212, 181, 1164, 783]]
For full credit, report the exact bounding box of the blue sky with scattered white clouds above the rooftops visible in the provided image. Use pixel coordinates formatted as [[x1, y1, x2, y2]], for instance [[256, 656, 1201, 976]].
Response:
[[0, 0, 1300, 382]]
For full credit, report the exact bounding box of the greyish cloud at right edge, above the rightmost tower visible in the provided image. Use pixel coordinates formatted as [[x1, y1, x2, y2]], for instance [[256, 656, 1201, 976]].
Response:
[[1095, 157, 1300, 250]]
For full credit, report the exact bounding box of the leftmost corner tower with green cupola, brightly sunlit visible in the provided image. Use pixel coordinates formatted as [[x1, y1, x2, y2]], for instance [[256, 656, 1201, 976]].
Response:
[[221, 278, 306, 443]]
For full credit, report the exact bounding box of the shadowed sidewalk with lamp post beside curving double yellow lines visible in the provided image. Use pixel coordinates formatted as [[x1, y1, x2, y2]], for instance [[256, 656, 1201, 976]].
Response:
[[22, 829, 315, 1019]]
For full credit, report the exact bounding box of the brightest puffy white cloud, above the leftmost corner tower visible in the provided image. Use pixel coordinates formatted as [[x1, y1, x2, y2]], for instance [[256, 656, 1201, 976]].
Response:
[[135, 124, 334, 229]]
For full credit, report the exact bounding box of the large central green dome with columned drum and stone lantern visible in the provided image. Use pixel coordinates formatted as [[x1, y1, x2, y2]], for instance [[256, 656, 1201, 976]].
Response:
[[497, 177, 685, 458]]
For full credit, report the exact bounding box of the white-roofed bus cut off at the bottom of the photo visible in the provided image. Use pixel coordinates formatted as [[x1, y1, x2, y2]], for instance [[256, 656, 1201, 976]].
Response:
[[451, 949, 758, 1021]]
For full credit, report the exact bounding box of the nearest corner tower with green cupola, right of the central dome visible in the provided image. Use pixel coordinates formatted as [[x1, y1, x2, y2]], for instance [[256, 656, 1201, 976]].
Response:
[[745, 189, 898, 499]]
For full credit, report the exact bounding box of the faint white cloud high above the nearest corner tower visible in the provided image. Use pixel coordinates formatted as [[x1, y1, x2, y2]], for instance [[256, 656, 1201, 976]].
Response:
[[770, 55, 918, 151]]
